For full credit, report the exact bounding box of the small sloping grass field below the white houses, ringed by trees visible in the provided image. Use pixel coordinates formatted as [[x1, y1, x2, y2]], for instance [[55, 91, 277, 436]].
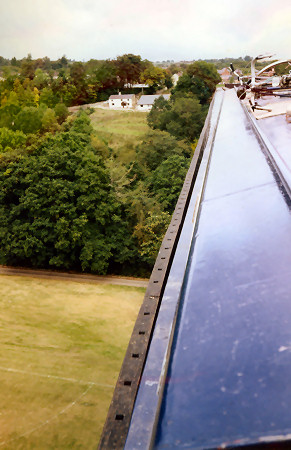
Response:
[[90, 109, 149, 163]]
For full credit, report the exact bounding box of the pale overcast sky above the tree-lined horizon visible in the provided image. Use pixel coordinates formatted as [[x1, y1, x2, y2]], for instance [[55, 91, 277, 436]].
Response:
[[0, 0, 291, 61]]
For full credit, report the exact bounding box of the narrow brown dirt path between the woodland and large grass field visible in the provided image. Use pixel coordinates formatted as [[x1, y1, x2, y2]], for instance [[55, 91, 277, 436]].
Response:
[[0, 265, 148, 288]]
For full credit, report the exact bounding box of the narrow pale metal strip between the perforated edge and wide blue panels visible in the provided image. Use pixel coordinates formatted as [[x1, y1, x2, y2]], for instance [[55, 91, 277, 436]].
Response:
[[124, 89, 224, 450]]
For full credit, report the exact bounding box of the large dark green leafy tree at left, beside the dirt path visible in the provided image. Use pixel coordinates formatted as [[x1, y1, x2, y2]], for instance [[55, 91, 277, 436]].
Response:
[[0, 121, 125, 273]]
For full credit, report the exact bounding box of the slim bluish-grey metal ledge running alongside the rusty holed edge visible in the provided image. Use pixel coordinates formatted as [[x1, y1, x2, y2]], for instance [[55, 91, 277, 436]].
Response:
[[125, 93, 222, 450]]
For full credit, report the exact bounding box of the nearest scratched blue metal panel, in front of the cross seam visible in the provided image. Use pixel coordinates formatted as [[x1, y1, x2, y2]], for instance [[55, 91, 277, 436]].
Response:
[[157, 186, 291, 448]]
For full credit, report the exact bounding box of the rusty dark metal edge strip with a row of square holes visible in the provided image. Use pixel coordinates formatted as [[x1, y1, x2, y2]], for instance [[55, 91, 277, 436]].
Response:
[[98, 96, 217, 450]]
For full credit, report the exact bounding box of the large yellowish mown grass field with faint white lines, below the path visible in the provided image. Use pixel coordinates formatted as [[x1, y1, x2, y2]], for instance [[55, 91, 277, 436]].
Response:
[[0, 276, 145, 450]]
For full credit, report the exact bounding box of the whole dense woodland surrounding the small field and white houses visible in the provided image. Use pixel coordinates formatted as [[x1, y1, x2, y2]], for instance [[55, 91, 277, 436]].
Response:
[[0, 55, 220, 275]]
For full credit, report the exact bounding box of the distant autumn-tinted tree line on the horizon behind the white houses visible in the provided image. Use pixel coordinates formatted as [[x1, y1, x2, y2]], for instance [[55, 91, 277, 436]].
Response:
[[0, 54, 172, 107]]
